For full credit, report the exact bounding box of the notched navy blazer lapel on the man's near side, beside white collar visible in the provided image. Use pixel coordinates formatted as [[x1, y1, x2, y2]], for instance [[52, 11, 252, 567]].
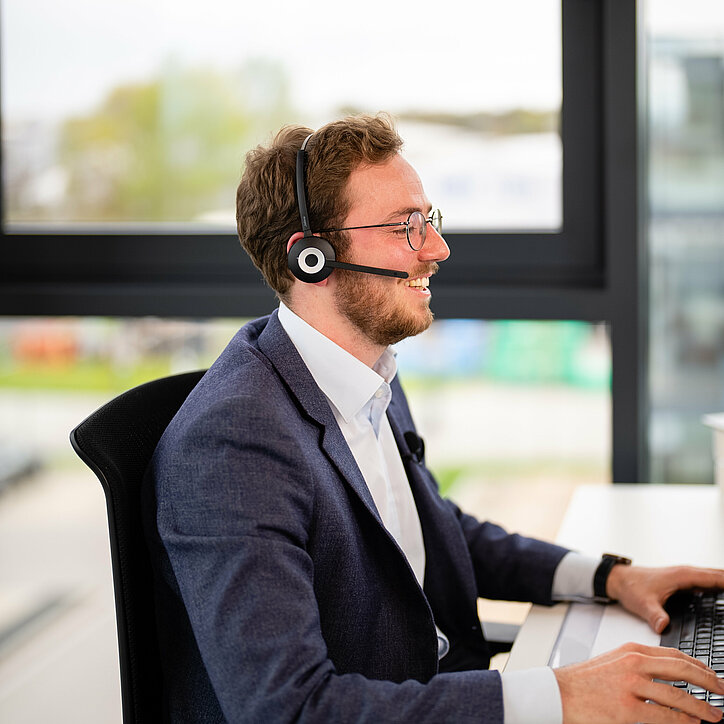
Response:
[[259, 310, 384, 527]]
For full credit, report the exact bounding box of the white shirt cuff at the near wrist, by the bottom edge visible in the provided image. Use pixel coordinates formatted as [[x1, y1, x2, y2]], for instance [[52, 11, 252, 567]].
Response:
[[500, 666, 563, 724]]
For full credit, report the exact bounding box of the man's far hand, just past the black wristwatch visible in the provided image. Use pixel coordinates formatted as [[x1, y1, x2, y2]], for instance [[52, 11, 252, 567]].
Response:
[[606, 565, 724, 633]]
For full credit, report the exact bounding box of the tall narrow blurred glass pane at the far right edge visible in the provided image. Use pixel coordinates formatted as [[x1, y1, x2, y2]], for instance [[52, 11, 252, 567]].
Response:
[[648, 0, 724, 483]]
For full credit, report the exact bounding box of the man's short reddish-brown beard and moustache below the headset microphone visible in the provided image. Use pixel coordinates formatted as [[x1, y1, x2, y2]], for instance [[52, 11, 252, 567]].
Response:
[[335, 264, 437, 347]]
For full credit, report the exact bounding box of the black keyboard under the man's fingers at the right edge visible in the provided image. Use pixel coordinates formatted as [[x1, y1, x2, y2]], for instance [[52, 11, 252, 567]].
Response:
[[661, 591, 724, 710]]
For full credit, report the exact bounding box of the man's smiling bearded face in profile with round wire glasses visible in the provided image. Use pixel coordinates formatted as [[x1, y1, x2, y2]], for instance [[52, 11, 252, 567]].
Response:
[[334, 155, 450, 346]]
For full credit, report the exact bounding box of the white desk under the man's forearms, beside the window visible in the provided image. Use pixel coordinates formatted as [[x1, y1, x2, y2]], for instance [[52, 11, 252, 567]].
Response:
[[505, 485, 724, 671]]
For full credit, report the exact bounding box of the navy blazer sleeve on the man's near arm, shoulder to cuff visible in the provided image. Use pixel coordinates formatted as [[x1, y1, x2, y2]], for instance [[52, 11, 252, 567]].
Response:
[[153, 395, 503, 724]]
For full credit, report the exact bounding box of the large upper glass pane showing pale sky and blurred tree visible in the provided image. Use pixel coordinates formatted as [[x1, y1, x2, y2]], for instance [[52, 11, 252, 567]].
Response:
[[2, 0, 562, 230]]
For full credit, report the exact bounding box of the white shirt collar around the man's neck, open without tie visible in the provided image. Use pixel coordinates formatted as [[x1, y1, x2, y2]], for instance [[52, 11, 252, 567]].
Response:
[[279, 302, 397, 422]]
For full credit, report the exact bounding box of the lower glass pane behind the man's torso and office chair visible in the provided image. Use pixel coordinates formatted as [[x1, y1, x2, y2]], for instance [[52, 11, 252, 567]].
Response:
[[0, 318, 610, 724]]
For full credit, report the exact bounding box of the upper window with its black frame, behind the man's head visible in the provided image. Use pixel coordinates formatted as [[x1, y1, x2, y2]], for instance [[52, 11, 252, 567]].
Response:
[[0, 0, 612, 319]]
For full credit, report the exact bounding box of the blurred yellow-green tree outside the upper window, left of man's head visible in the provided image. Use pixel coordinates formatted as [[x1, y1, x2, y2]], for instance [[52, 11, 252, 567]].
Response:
[[59, 60, 294, 221]]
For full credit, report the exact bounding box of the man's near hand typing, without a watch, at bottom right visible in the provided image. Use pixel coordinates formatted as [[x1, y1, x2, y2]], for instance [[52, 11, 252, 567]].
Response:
[[553, 643, 724, 724]]
